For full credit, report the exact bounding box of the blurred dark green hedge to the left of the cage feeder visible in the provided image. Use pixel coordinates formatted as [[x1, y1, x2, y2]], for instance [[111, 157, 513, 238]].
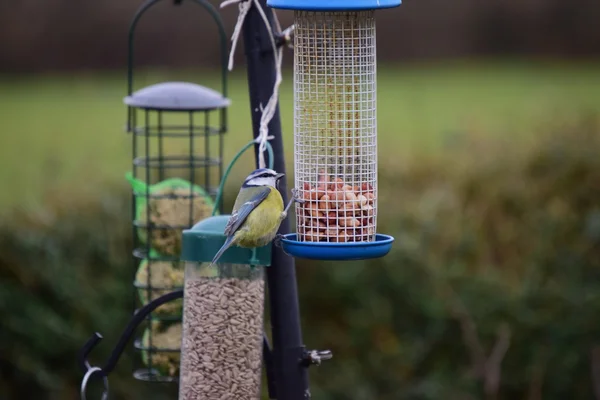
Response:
[[0, 188, 176, 400]]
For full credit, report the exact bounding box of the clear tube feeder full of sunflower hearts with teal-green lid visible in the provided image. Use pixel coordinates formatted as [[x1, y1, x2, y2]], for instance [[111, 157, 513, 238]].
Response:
[[179, 216, 271, 400]]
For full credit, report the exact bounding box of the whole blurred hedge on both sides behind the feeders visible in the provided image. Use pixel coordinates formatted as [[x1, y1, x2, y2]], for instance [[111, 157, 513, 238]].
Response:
[[0, 114, 600, 400]]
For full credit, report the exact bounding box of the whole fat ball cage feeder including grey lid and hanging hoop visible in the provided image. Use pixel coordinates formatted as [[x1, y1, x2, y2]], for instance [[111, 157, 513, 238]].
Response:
[[123, 0, 230, 382]]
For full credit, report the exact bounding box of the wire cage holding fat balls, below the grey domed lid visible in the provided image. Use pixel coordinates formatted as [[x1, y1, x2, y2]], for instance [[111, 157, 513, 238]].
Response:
[[132, 109, 223, 382]]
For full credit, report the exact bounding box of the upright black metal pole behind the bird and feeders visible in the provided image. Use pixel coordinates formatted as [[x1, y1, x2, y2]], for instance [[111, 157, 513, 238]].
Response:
[[243, 0, 310, 400]]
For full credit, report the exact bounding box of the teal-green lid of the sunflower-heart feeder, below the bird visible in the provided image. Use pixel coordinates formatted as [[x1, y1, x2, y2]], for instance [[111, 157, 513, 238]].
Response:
[[181, 215, 271, 266]]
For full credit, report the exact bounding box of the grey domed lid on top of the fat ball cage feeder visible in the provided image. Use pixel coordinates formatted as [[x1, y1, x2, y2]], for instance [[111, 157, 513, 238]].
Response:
[[124, 82, 231, 111]]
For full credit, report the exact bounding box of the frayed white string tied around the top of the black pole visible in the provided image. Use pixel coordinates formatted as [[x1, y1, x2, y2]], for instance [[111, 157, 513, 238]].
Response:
[[220, 0, 291, 168]]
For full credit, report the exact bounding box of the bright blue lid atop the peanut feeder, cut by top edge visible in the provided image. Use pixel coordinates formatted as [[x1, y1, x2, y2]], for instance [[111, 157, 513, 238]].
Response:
[[267, 0, 402, 11]]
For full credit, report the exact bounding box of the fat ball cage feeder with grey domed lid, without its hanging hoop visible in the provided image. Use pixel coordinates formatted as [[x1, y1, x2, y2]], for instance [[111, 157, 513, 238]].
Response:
[[125, 82, 229, 381]]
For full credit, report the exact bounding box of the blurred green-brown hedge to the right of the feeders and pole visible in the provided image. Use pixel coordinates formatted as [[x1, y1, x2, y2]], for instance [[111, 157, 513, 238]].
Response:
[[299, 114, 600, 400]]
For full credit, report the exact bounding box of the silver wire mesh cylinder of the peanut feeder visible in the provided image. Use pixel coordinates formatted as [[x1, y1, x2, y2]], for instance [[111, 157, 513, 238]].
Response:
[[294, 10, 377, 242]]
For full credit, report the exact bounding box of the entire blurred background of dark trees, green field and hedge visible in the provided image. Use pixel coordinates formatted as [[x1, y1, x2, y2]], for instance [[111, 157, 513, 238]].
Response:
[[0, 0, 600, 400]]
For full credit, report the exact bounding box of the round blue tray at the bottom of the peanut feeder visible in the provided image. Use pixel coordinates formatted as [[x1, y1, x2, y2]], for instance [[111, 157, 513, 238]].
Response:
[[281, 233, 394, 261]]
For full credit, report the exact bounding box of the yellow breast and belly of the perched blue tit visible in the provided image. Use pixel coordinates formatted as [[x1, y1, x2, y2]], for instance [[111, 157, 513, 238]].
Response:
[[236, 188, 284, 247]]
